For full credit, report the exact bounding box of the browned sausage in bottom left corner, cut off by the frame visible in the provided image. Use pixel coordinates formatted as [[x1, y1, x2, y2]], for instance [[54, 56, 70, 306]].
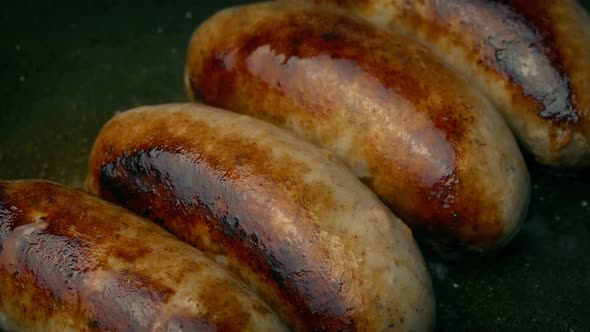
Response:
[[0, 180, 286, 331]]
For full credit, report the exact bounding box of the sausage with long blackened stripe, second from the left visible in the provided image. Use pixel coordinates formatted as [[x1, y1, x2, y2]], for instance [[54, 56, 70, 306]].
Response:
[[86, 103, 435, 331]]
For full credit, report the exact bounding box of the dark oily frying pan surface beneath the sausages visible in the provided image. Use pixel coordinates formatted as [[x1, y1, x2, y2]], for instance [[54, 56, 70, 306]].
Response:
[[0, 0, 590, 331]]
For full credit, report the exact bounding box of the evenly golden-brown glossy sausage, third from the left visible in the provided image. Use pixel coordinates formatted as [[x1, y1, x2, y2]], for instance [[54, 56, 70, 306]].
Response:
[[186, 3, 530, 254]]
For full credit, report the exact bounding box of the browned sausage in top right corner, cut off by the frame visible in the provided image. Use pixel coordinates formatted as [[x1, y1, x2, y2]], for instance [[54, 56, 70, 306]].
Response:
[[290, 0, 590, 167]]
